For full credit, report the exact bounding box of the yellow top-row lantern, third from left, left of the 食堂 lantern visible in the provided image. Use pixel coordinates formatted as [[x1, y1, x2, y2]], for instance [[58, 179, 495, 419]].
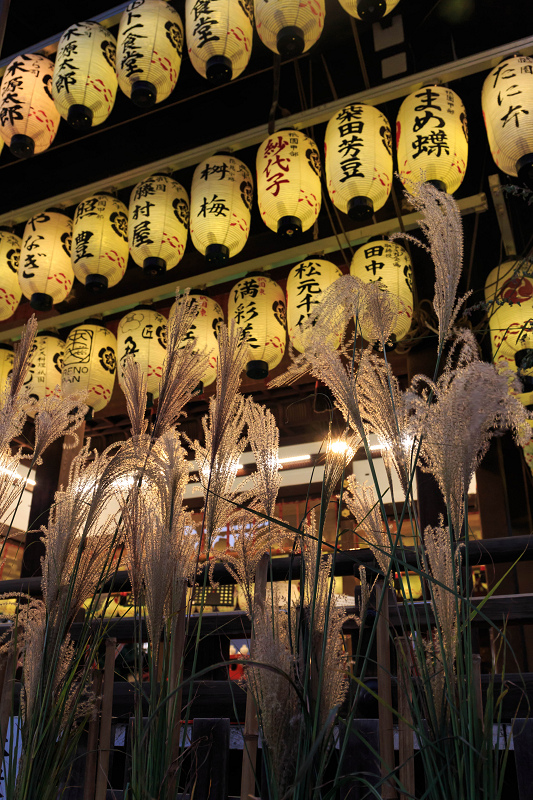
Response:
[[117, 0, 183, 108]]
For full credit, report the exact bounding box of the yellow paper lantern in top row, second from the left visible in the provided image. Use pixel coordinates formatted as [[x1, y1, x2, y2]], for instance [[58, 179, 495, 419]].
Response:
[[52, 20, 118, 130]]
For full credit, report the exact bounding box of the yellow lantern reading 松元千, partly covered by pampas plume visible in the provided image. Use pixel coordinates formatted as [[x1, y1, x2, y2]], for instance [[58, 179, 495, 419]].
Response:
[[287, 259, 342, 353]]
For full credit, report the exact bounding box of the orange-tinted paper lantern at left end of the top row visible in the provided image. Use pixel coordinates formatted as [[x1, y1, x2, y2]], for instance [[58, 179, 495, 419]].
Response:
[[0, 55, 60, 158]]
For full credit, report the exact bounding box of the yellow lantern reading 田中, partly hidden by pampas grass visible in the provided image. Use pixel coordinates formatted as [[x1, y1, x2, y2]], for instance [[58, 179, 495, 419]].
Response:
[[350, 239, 413, 342]]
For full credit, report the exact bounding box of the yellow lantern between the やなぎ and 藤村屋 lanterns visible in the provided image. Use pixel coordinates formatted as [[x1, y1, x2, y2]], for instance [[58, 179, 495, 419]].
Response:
[[72, 192, 129, 291]]
